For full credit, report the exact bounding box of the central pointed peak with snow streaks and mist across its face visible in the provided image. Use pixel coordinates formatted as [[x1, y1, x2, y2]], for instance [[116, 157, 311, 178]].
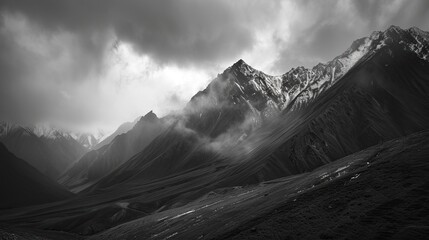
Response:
[[184, 60, 285, 138]]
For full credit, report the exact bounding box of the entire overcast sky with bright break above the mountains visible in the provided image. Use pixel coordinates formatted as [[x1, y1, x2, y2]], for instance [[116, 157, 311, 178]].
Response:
[[0, 0, 429, 133]]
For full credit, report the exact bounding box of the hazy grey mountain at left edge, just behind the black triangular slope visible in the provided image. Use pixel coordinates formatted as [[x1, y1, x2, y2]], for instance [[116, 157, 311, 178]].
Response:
[[0, 122, 87, 179]]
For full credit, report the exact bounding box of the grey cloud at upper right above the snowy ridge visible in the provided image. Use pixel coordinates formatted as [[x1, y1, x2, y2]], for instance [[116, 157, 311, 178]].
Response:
[[273, 0, 429, 71]]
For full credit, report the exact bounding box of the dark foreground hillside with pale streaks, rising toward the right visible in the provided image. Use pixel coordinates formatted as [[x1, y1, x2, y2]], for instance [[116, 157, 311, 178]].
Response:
[[0, 132, 429, 239]]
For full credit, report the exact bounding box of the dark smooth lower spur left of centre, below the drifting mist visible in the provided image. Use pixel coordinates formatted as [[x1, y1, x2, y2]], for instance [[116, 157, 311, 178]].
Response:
[[88, 125, 216, 191]]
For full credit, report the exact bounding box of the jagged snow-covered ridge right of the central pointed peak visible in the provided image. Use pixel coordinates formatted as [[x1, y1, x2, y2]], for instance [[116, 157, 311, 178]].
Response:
[[258, 26, 429, 109]]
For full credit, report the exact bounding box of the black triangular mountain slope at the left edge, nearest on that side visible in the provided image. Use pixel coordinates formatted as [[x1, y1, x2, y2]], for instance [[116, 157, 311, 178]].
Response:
[[0, 143, 71, 209]]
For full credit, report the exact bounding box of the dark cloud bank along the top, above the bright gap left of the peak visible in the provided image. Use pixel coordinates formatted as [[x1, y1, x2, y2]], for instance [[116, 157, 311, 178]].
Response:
[[0, 0, 275, 65]]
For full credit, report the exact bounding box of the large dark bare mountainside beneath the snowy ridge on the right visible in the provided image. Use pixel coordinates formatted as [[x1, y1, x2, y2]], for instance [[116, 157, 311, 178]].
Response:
[[213, 38, 429, 184]]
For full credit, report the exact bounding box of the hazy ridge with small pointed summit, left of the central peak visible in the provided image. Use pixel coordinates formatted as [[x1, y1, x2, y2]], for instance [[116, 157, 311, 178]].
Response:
[[59, 111, 164, 190]]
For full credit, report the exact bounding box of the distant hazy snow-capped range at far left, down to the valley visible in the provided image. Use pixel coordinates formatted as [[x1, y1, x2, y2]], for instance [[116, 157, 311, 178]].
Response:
[[0, 122, 135, 179]]
